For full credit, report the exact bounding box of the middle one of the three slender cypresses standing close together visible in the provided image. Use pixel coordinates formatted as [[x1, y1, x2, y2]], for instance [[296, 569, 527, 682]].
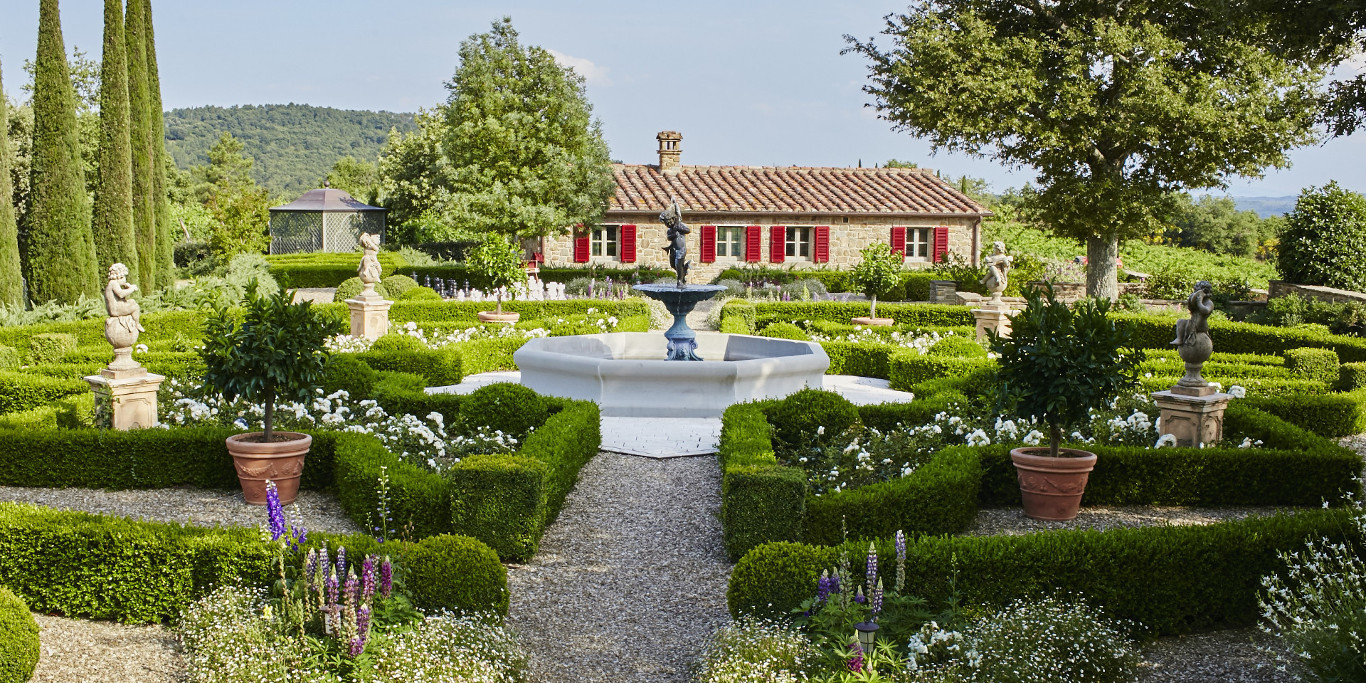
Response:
[[123, 0, 157, 292]]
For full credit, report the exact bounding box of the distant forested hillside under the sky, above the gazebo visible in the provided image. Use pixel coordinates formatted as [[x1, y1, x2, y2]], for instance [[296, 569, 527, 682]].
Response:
[[167, 104, 415, 195]]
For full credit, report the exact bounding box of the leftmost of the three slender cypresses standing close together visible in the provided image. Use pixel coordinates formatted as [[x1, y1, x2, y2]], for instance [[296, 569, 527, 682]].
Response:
[[93, 0, 139, 283]]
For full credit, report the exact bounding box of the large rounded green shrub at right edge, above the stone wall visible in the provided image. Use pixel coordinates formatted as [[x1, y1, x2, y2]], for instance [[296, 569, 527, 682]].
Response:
[[1276, 180, 1366, 291]]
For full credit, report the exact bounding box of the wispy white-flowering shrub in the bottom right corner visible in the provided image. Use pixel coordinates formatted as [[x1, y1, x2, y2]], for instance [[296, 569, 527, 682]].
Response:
[[1258, 500, 1366, 682]]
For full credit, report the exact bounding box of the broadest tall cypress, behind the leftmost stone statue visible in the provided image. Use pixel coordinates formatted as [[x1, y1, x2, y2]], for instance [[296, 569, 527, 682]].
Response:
[[27, 0, 100, 303]]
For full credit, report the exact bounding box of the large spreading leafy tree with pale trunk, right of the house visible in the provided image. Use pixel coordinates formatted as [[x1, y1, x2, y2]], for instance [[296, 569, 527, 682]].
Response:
[[847, 0, 1324, 299]]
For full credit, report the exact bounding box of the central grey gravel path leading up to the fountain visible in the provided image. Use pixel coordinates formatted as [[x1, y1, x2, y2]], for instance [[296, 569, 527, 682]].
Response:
[[508, 454, 731, 683]]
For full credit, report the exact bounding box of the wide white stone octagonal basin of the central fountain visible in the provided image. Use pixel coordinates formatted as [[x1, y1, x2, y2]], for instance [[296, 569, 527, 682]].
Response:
[[512, 332, 831, 418]]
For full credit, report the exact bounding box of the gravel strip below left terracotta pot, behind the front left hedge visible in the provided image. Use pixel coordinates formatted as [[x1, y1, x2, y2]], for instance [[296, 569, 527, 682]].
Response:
[[0, 486, 363, 534]]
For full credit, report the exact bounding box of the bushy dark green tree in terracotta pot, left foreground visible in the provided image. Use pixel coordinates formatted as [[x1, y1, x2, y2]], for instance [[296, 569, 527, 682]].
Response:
[[199, 283, 342, 505]]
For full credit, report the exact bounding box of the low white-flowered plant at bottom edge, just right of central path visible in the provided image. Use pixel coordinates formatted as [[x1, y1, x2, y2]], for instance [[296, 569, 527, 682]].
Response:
[[697, 617, 821, 683]]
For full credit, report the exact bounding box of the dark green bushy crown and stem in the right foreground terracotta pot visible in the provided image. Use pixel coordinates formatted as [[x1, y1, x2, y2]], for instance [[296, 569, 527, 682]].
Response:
[[990, 283, 1143, 458]]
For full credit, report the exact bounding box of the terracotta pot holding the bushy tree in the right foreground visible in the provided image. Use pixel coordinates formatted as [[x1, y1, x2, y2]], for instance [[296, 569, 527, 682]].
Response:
[[1011, 447, 1096, 522]]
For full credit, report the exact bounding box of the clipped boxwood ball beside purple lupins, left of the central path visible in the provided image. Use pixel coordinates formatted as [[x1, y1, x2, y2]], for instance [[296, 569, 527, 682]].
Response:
[[403, 534, 508, 615]]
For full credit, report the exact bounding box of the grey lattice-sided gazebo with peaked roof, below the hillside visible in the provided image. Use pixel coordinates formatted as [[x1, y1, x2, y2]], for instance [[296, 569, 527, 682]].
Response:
[[270, 187, 385, 254]]
